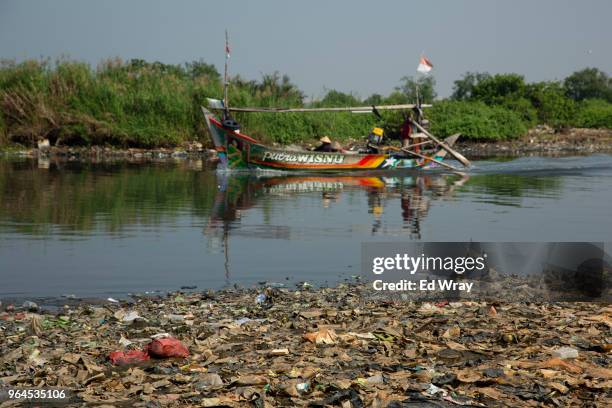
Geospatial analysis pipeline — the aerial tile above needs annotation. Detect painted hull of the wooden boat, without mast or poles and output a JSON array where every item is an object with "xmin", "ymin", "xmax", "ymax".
[{"xmin": 202, "ymin": 107, "xmax": 459, "ymax": 173}]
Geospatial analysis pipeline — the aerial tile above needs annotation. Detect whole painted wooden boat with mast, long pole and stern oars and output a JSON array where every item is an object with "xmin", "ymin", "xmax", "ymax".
[{"xmin": 202, "ymin": 31, "xmax": 469, "ymax": 173}]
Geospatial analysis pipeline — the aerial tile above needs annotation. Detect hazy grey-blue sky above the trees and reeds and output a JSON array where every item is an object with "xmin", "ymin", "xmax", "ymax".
[{"xmin": 0, "ymin": 0, "xmax": 612, "ymax": 97}]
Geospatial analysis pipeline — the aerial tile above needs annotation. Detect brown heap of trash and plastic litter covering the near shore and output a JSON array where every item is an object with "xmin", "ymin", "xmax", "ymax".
[{"xmin": 0, "ymin": 284, "xmax": 612, "ymax": 408}]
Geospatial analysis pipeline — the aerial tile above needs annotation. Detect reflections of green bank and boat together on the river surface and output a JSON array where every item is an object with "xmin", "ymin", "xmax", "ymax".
[{"xmin": 0, "ymin": 160, "xmax": 561, "ymax": 239}]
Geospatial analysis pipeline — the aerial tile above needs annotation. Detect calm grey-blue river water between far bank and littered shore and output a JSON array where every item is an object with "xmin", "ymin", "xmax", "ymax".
[{"xmin": 0, "ymin": 155, "xmax": 612, "ymax": 298}]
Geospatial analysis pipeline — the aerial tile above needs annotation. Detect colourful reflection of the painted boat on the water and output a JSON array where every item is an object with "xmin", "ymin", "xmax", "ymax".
[{"xmin": 205, "ymin": 173, "xmax": 469, "ymax": 239}]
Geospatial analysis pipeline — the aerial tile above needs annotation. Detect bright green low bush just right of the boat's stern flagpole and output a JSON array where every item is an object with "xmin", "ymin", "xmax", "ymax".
[{"xmin": 430, "ymin": 101, "xmax": 527, "ymax": 140}]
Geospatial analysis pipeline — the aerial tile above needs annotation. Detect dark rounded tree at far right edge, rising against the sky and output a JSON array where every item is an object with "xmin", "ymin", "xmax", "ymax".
[{"xmin": 563, "ymin": 68, "xmax": 612, "ymax": 102}]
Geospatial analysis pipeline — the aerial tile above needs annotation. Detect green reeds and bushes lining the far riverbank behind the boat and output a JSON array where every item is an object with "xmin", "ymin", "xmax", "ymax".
[{"xmin": 0, "ymin": 60, "xmax": 612, "ymax": 147}]
